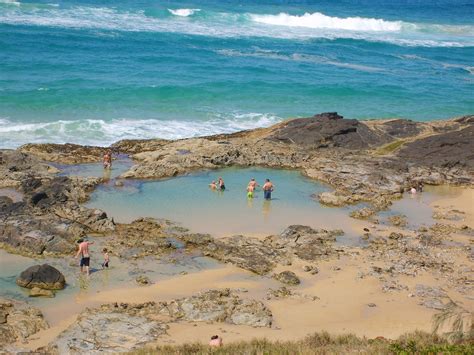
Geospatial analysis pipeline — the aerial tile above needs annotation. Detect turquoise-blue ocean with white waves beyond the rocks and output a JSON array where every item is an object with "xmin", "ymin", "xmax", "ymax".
[{"xmin": 0, "ymin": 0, "xmax": 474, "ymax": 148}]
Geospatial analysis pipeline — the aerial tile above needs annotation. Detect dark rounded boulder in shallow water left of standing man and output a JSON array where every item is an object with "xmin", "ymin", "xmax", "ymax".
[{"xmin": 16, "ymin": 264, "xmax": 66, "ymax": 290}]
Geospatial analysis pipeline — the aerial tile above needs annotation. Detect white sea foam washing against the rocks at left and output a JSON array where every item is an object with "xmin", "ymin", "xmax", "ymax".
[{"xmin": 0, "ymin": 113, "xmax": 281, "ymax": 148}]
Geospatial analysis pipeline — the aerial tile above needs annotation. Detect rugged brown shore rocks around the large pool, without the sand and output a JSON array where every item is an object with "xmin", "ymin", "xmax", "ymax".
[{"xmin": 0, "ymin": 113, "xmax": 474, "ymax": 351}]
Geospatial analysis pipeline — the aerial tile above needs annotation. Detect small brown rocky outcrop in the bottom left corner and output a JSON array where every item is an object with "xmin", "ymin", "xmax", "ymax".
[{"xmin": 0, "ymin": 298, "xmax": 48, "ymax": 352}]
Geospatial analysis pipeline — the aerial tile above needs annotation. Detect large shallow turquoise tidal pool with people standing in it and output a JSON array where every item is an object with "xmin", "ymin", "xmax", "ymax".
[{"xmin": 88, "ymin": 168, "xmax": 362, "ymax": 236}]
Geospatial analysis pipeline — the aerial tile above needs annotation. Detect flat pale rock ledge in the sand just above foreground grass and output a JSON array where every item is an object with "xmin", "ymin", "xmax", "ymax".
[{"xmin": 46, "ymin": 289, "xmax": 272, "ymax": 354}]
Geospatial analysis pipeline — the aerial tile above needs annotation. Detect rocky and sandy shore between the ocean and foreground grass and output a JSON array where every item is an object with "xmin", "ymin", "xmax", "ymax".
[{"xmin": 0, "ymin": 114, "xmax": 474, "ymax": 350}]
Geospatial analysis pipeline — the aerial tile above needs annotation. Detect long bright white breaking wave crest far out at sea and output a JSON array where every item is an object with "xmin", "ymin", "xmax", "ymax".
[{"xmin": 251, "ymin": 12, "xmax": 402, "ymax": 32}]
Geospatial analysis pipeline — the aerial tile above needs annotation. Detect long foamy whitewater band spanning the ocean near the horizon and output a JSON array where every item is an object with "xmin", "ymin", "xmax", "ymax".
[{"xmin": 0, "ymin": 5, "xmax": 474, "ymax": 47}]
